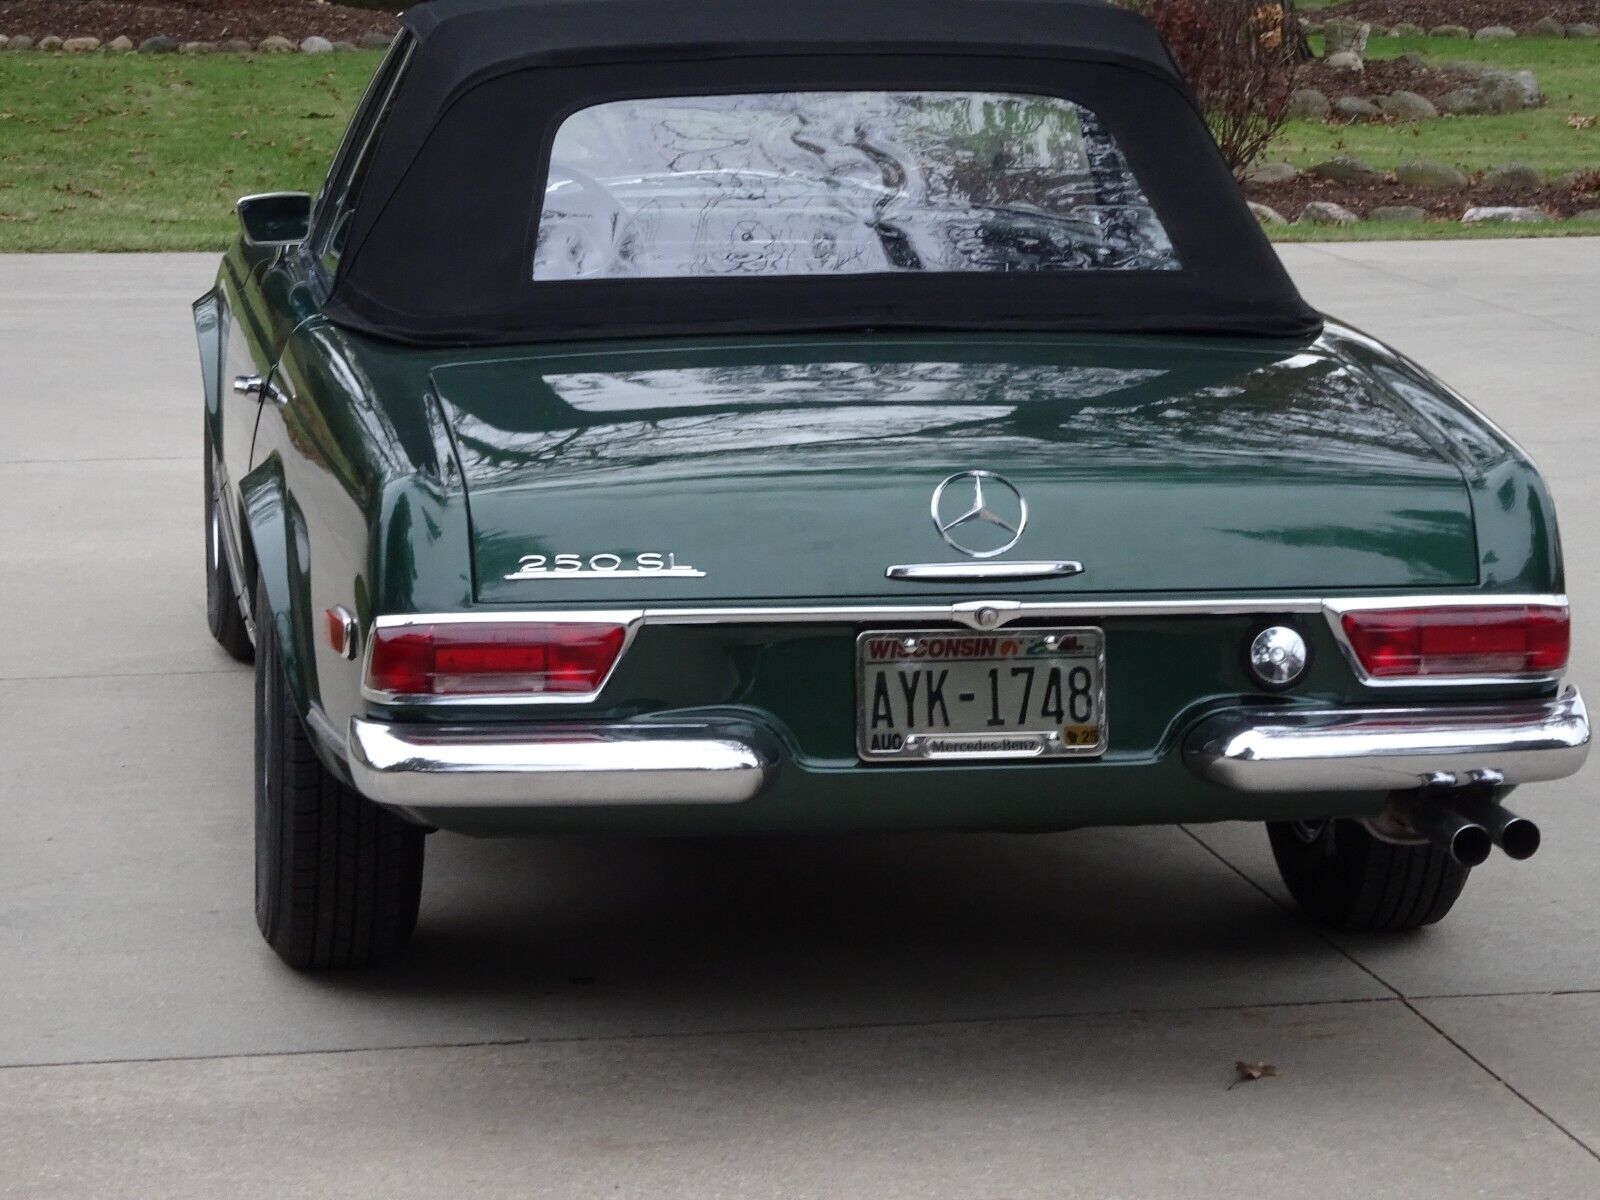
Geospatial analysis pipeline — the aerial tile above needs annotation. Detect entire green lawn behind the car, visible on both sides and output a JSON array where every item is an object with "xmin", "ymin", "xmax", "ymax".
[{"xmin": 0, "ymin": 37, "xmax": 1600, "ymax": 251}]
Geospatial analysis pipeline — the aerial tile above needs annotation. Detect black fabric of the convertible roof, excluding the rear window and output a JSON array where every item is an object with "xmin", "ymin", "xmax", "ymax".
[{"xmin": 325, "ymin": 0, "xmax": 1320, "ymax": 346}]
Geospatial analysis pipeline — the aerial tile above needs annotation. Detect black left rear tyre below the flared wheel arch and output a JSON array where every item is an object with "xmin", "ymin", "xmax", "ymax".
[{"xmin": 256, "ymin": 586, "xmax": 424, "ymax": 970}]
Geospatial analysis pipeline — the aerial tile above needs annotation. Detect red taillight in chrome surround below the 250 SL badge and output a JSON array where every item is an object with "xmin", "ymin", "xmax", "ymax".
[{"xmin": 366, "ymin": 621, "xmax": 627, "ymax": 696}]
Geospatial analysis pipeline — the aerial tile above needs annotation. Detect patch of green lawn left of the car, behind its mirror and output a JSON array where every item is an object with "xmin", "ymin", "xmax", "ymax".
[{"xmin": 0, "ymin": 51, "xmax": 381, "ymax": 251}]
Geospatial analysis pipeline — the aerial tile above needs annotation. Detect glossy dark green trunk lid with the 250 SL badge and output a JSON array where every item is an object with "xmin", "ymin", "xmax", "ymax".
[{"xmin": 434, "ymin": 338, "xmax": 1477, "ymax": 606}]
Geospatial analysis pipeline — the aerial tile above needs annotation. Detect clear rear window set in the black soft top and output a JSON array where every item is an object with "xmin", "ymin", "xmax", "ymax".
[{"xmin": 533, "ymin": 91, "xmax": 1179, "ymax": 280}]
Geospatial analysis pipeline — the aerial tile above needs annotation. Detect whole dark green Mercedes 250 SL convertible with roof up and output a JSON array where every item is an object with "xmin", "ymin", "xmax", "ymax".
[{"xmin": 195, "ymin": 0, "xmax": 1589, "ymax": 968}]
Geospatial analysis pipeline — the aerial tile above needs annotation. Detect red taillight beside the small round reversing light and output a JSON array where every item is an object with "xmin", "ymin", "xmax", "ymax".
[{"xmin": 1341, "ymin": 605, "xmax": 1570, "ymax": 678}]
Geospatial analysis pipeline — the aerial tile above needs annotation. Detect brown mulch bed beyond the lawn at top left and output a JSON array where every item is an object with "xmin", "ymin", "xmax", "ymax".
[{"xmin": 0, "ymin": 0, "xmax": 395, "ymax": 42}]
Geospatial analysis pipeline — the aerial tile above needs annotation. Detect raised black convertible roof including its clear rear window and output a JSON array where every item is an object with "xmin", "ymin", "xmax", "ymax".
[{"xmin": 323, "ymin": 0, "xmax": 1320, "ymax": 346}]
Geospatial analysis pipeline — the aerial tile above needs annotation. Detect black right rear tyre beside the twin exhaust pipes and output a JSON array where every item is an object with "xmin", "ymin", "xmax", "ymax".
[{"xmin": 1267, "ymin": 821, "xmax": 1472, "ymax": 933}]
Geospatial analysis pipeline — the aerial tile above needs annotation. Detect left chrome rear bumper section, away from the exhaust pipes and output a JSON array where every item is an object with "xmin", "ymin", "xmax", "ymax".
[{"xmin": 349, "ymin": 717, "xmax": 778, "ymax": 810}]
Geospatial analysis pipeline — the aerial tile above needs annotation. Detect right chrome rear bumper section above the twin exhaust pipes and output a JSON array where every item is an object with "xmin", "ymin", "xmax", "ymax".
[{"xmin": 1184, "ymin": 688, "xmax": 1589, "ymax": 792}]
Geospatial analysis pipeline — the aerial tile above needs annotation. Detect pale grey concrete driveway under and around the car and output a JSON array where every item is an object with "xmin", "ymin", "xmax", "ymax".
[{"xmin": 0, "ymin": 240, "xmax": 1600, "ymax": 1200}]
